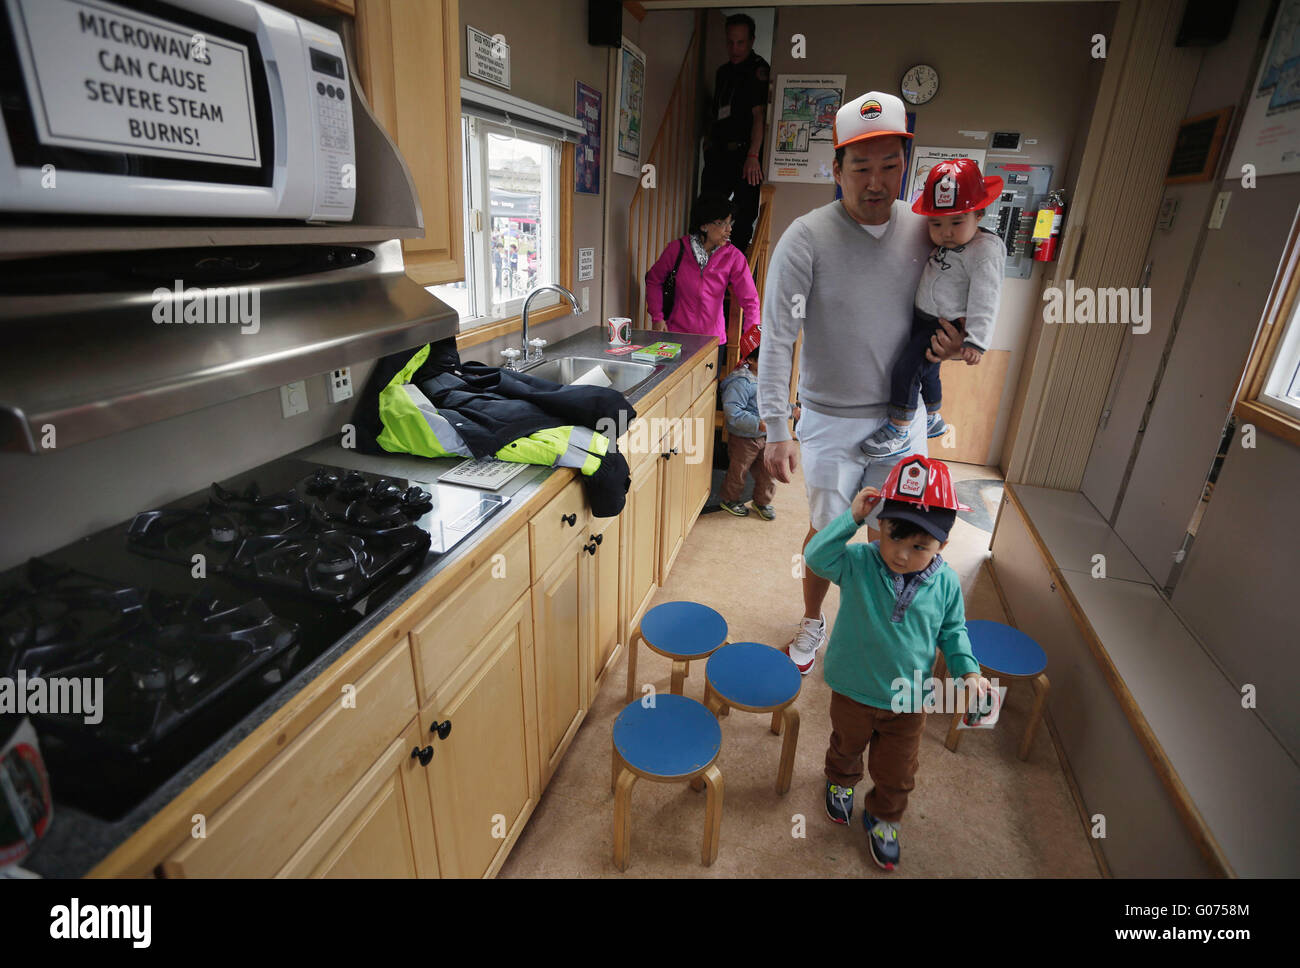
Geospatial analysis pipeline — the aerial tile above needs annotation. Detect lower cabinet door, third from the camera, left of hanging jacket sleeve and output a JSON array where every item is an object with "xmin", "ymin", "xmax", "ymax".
[{"xmin": 533, "ymin": 540, "xmax": 590, "ymax": 787}]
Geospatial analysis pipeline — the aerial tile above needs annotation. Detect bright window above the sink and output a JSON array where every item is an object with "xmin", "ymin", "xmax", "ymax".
[{"xmin": 429, "ymin": 117, "xmax": 562, "ymax": 333}]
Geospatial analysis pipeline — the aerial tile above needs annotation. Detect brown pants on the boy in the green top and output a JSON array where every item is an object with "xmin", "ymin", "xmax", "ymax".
[{"xmin": 826, "ymin": 693, "xmax": 926, "ymax": 824}]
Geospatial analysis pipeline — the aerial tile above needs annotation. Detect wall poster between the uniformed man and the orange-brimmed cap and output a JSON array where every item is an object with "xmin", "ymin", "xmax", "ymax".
[{"xmin": 767, "ymin": 74, "xmax": 848, "ymax": 185}]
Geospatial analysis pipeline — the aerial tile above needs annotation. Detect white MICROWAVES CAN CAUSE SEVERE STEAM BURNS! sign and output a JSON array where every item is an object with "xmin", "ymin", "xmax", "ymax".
[{"xmin": 8, "ymin": 0, "xmax": 261, "ymax": 168}]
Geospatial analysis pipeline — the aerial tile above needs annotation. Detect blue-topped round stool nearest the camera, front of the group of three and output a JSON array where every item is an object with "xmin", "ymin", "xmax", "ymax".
[{"xmin": 610, "ymin": 694, "xmax": 723, "ymax": 871}]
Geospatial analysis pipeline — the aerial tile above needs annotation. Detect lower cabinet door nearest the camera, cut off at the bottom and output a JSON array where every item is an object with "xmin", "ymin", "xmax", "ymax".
[{"xmin": 276, "ymin": 719, "xmax": 438, "ymax": 877}]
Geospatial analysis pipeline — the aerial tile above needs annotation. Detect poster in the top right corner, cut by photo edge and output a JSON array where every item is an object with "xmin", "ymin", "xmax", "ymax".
[{"xmin": 1223, "ymin": 0, "xmax": 1300, "ymax": 178}]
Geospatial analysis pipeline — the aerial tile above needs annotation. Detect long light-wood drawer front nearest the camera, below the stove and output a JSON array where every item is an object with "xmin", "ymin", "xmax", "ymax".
[{"xmin": 163, "ymin": 639, "xmax": 417, "ymax": 877}]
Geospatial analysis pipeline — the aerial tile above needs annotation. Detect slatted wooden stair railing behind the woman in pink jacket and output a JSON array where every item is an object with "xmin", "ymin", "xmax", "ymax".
[{"xmin": 628, "ymin": 16, "xmax": 703, "ymax": 329}]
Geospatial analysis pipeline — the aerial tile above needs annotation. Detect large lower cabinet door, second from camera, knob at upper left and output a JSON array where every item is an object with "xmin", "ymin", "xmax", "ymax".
[{"xmin": 419, "ymin": 594, "xmax": 538, "ymax": 877}]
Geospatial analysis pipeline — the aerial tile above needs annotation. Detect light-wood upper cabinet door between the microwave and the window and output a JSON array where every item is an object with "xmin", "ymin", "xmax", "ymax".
[{"xmin": 356, "ymin": 0, "xmax": 465, "ymax": 286}]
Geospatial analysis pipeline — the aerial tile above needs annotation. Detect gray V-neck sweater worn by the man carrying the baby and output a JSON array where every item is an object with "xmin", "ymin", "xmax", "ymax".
[{"xmin": 758, "ymin": 199, "xmax": 932, "ymax": 443}]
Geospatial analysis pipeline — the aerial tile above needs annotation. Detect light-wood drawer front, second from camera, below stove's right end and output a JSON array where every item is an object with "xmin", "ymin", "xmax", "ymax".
[{"xmin": 411, "ymin": 527, "xmax": 525, "ymax": 703}]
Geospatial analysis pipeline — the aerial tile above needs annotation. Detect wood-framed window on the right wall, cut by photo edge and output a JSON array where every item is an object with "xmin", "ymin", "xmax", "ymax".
[{"xmin": 1235, "ymin": 209, "xmax": 1300, "ymax": 446}]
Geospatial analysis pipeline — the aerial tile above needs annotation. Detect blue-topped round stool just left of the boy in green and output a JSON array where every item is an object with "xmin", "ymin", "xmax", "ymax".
[{"xmin": 705, "ymin": 642, "xmax": 803, "ymax": 794}]
